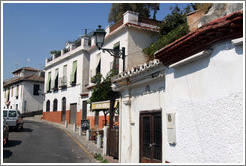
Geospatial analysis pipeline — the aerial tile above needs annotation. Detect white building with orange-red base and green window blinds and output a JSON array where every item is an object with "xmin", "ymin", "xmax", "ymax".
[{"xmin": 43, "ymin": 36, "xmax": 90, "ymax": 124}]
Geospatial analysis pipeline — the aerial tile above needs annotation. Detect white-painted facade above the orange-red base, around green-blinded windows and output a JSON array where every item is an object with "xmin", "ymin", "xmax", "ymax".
[{"xmin": 43, "ymin": 37, "xmax": 90, "ymax": 123}]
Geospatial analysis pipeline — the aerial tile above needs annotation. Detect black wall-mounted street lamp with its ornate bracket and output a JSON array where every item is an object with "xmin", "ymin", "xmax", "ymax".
[{"xmin": 93, "ymin": 25, "xmax": 125, "ymax": 71}]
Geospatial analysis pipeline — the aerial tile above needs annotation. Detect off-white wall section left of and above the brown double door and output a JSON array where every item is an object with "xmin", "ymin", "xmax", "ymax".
[{"xmin": 119, "ymin": 79, "xmax": 165, "ymax": 163}]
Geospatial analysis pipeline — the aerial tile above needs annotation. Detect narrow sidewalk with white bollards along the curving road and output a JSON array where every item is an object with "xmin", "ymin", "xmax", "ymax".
[{"xmin": 24, "ymin": 116, "xmax": 118, "ymax": 163}]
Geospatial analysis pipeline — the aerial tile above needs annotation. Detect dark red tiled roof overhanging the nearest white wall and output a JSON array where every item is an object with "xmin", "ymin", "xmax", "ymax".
[{"xmin": 155, "ymin": 11, "xmax": 243, "ymax": 66}]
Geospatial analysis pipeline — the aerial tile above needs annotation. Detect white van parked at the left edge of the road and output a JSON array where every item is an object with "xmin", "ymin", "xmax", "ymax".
[{"xmin": 3, "ymin": 109, "xmax": 24, "ymax": 131}]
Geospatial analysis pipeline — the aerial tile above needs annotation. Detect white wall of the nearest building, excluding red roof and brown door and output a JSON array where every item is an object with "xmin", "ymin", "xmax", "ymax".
[{"xmin": 114, "ymin": 39, "xmax": 244, "ymax": 163}]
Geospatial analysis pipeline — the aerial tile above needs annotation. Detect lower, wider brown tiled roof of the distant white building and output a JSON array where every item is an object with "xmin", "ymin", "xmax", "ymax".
[{"xmin": 3, "ymin": 74, "xmax": 44, "ymax": 87}]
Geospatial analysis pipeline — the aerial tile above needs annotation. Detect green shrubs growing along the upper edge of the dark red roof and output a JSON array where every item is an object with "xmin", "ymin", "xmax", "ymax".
[{"xmin": 144, "ymin": 23, "xmax": 189, "ymax": 60}]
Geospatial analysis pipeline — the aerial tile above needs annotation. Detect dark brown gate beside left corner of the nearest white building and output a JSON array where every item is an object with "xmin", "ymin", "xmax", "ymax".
[{"xmin": 107, "ymin": 128, "xmax": 119, "ymax": 159}]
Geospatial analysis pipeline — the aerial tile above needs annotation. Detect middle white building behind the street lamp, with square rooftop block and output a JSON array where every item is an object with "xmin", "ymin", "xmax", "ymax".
[{"xmin": 87, "ymin": 11, "xmax": 159, "ymax": 128}]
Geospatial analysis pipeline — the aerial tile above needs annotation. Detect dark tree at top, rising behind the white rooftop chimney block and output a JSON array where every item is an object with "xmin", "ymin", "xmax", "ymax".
[{"xmin": 108, "ymin": 3, "xmax": 160, "ymax": 23}]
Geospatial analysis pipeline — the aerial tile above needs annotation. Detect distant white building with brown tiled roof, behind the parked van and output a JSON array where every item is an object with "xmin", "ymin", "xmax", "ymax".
[{"xmin": 3, "ymin": 67, "xmax": 44, "ymax": 114}]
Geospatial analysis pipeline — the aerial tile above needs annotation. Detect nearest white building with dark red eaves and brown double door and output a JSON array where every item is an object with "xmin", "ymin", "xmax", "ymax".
[{"xmin": 113, "ymin": 11, "xmax": 245, "ymax": 163}]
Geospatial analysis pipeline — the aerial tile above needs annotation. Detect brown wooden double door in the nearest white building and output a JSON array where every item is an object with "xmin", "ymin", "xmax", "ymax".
[{"xmin": 140, "ymin": 111, "xmax": 162, "ymax": 163}]
